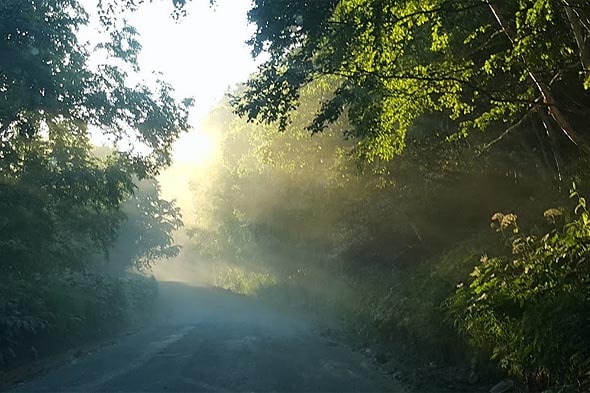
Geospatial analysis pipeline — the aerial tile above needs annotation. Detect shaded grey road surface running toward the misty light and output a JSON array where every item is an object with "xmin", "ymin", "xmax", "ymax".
[{"xmin": 12, "ymin": 283, "xmax": 404, "ymax": 393}]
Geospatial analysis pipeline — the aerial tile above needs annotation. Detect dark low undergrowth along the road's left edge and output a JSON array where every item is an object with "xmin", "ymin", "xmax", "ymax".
[{"xmin": 0, "ymin": 270, "xmax": 157, "ymax": 368}]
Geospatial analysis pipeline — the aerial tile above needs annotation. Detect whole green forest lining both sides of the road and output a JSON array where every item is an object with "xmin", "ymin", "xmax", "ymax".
[{"xmin": 0, "ymin": 0, "xmax": 590, "ymax": 392}]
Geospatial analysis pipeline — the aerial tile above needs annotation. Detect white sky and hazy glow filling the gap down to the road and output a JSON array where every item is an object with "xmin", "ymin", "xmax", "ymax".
[{"xmin": 80, "ymin": 0, "xmax": 264, "ymax": 285}]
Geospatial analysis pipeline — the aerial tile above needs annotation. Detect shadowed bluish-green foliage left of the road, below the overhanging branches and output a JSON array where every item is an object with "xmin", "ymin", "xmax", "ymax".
[{"xmin": 0, "ymin": 132, "xmax": 181, "ymax": 366}]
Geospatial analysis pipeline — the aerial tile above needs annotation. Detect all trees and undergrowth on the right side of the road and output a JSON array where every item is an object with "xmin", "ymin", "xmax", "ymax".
[{"xmin": 190, "ymin": 0, "xmax": 590, "ymax": 391}]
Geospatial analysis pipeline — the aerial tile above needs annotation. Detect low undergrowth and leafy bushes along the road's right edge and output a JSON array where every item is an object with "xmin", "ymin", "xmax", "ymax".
[{"xmin": 223, "ymin": 188, "xmax": 590, "ymax": 391}]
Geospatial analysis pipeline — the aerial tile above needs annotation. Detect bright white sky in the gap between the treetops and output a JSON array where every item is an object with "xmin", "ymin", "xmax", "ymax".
[{"xmin": 83, "ymin": 0, "xmax": 257, "ymax": 163}]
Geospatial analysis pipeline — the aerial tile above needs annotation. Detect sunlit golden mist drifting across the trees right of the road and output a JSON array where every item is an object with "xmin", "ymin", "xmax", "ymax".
[{"xmin": 148, "ymin": 82, "xmax": 529, "ymax": 329}]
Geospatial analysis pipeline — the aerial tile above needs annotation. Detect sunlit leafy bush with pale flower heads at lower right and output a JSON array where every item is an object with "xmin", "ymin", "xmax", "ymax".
[{"xmin": 451, "ymin": 188, "xmax": 590, "ymax": 387}]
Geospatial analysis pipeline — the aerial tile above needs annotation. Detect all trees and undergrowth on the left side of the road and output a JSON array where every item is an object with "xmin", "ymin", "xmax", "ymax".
[{"xmin": 0, "ymin": 0, "xmax": 185, "ymax": 370}]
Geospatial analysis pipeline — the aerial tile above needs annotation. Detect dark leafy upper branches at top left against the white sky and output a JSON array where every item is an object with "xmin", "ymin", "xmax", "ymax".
[{"xmin": 0, "ymin": 0, "xmax": 192, "ymax": 177}]
